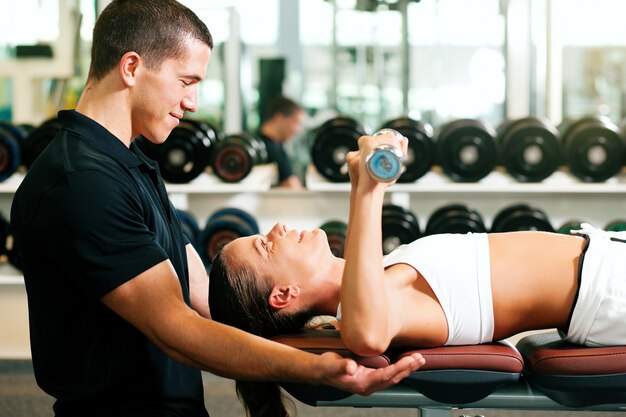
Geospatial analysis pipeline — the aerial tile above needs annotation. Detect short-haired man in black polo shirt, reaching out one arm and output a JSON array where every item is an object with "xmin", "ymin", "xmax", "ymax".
[{"xmin": 11, "ymin": 0, "xmax": 424, "ymax": 417}]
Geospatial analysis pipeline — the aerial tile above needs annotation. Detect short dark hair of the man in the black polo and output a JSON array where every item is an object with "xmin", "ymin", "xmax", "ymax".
[{"xmin": 89, "ymin": 0, "xmax": 213, "ymax": 81}]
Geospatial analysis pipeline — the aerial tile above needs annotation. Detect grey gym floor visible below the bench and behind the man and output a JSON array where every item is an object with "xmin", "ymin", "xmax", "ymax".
[{"xmin": 0, "ymin": 360, "xmax": 624, "ymax": 417}]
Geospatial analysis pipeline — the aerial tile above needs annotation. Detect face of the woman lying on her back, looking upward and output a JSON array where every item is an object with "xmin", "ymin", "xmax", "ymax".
[{"xmin": 227, "ymin": 223, "xmax": 334, "ymax": 285}]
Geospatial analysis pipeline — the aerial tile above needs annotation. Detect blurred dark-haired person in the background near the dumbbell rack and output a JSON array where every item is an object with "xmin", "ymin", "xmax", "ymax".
[{"xmin": 257, "ymin": 96, "xmax": 306, "ymax": 190}]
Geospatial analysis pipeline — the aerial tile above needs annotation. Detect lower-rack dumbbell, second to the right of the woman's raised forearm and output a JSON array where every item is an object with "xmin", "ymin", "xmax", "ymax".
[{"xmin": 424, "ymin": 204, "xmax": 487, "ymax": 235}]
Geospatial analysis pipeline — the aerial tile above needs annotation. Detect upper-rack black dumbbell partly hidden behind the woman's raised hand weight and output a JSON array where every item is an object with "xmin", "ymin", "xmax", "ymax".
[{"xmin": 381, "ymin": 117, "xmax": 436, "ymax": 183}]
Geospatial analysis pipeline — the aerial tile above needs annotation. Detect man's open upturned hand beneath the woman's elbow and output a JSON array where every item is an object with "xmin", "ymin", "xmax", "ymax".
[{"xmin": 318, "ymin": 352, "xmax": 425, "ymax": 395}]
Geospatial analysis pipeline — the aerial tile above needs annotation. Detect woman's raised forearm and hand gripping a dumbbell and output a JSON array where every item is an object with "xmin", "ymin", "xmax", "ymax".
[{"xmin": 341, "ymin": 134, "xmax": 407, "ymax": 356}]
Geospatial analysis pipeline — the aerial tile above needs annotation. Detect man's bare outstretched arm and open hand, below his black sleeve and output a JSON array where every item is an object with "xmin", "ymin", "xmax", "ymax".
[{"xmin": 102, "ymin": 261, "xmax": 423, "ymax": 395}]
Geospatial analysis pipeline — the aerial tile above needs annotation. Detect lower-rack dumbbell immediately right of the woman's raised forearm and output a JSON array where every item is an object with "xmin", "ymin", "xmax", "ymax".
[{"xmin": 382, "ymin": 204, "xmax": 421, "ymax": 255}]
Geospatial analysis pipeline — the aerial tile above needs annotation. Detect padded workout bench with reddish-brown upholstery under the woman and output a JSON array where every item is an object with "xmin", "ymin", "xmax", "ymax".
[{"xmin": 274, "ymin": 330, "xmax": 626, "ymax": 417}]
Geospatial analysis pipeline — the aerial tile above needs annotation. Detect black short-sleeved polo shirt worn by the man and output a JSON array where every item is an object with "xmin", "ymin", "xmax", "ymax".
[{"xmin": 11, "ymin": 111, "xmax": 207, "ymax": 417}]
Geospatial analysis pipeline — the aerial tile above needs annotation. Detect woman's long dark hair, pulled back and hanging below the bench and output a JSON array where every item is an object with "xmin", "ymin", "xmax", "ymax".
[{"xmin": 209, "ymin": 246, "xmax": 313, "ymax": 417}]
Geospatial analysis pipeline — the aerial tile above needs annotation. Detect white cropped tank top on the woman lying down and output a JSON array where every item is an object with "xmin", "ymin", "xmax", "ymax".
[{"xmin": 383, "ymin": 233, "xmax": 494, "ymax": 345}]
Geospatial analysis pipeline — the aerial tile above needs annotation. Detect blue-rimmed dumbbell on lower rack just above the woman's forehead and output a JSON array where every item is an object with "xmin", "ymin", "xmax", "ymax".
[{"xmin": 198, "ymin": 207, "xmax": 259, "ymax": 266}]
